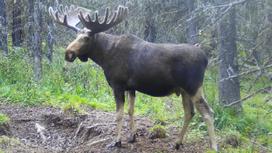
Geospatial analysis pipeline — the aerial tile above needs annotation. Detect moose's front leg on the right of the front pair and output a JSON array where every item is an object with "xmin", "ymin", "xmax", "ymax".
[{"xmin": 128, "ymin": 91, "xmax": 136, "ymax": 143}]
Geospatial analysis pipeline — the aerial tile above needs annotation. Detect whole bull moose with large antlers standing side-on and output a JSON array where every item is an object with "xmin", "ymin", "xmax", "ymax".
[{"xmin": 49, "ymin": 5, "xmax": 217, "ymax": 150}]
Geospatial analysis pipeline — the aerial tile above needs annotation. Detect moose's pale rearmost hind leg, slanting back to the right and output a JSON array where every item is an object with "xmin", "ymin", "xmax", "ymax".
[{"xmin": 192, "ymin": 87, "xmax": 218, "ymax": 151}]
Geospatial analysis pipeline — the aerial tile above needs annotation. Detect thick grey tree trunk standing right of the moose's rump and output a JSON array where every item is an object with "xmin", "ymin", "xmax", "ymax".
[{"xmin": 218, "ymin": 6, "xmax": 242, "ymax": 113}]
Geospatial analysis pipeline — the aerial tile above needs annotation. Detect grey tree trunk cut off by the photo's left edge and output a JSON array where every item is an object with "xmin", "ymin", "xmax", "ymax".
[{"xmin": 0, "ymin": 0, "xmax": 8, "ymax": 56}]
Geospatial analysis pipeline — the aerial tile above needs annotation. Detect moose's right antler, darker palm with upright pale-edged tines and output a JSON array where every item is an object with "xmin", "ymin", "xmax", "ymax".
[{"xmin": 78, "ymin": 6, "xmax": 128, "ymax": 34}]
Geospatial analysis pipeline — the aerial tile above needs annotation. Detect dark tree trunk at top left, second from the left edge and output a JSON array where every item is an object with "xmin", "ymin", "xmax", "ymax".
[{"xmin": 12, "ymin": 0, "xmax": 23, "ymax": 47}]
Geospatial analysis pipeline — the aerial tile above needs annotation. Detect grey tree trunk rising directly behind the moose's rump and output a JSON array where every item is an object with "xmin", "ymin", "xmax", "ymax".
[{"xmin": 186, "ymin": 0, "xmax": 198, "ymax": 44}]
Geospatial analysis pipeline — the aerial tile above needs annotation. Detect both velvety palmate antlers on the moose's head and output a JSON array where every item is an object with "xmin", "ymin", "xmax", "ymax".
[{"xmin": 49, "ymin": 5, "xmax": 128, "ymax": 34}]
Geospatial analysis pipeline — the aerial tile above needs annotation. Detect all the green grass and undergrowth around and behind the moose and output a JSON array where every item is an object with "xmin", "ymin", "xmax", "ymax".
[{"xmin": 0, "ymin": 49, "xmax": 272, "ymax": 152}]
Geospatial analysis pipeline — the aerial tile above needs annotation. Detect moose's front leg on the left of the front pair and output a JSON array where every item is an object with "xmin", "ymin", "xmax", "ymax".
[{"xmin": 111, "ymin": 89, "xmax": 125, "ymax": 147}]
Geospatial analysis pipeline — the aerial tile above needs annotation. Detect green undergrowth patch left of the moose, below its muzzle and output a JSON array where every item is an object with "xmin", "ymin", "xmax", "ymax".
[{"xmin": 0, "ymin": 47, "xmax": 113, "ymax": 106}]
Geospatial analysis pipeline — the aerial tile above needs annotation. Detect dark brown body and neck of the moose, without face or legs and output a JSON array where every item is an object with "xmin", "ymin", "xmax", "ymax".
[{"xmin": 71, "ymin": 33, "xmax": 207, "ymax": 96}]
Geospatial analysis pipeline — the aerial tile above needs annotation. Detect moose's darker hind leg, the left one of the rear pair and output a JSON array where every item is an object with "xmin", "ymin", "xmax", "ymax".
[{"xmin": 176, "ymin": 92, "xmax": 195, "ymax": 149}]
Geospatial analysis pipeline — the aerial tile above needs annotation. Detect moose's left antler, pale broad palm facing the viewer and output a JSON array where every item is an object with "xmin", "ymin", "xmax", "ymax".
[{"xmin": 49, "ymin": 5, "xmax": 90, "ymax": 32}]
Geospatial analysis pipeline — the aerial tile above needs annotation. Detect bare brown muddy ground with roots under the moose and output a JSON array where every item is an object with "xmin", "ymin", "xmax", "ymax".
[{"xmin": 0, "ymin": 104, "xmax": 209, "ymax": 153}]
